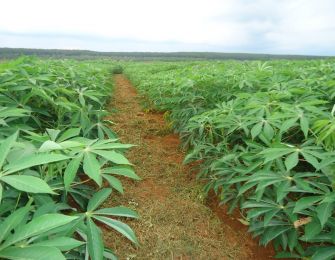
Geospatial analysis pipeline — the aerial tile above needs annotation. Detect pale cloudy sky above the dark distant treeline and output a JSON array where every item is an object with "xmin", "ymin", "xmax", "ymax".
[{"xmin": 0, "ymin": 0, "xmax": 335, "ymax": 55}]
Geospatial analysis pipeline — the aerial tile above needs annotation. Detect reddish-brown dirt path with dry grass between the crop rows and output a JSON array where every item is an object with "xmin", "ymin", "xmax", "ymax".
[{"xmin": 105, "ymin": 75, "xmax": 273, "ymax": 259}]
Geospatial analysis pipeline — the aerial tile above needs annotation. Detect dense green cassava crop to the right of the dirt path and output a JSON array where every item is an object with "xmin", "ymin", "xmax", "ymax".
[{"xmin": 124, "ymin": 60, "xmax": 335, "ymax": 259}]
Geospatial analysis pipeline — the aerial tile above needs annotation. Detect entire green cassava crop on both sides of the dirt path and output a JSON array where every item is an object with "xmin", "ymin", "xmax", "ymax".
[{"xmin": 0, "ymin": 57, "xmax": 335, "ymax": 260}]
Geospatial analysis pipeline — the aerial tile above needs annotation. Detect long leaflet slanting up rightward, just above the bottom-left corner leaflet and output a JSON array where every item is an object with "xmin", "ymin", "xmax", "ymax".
[{"xmin": 0, "ymin": 213, "xmax": 78, "ymax": 250}]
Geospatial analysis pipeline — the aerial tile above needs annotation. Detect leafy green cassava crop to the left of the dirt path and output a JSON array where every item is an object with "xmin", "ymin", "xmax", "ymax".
[{"xmin": 0, "ymin": 58, "xmax": 139, "ymax": 260}]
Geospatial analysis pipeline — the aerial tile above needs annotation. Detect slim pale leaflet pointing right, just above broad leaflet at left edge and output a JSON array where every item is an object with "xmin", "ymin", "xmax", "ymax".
[{"xmin": 4, "ymin": 153, "xmax": 70, "ymax": 174}]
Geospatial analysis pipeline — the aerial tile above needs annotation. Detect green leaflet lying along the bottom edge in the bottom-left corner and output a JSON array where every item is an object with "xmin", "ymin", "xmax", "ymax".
[{"xmin": 0, "ymin": 246, "xmax": 65, "ymax": 260}]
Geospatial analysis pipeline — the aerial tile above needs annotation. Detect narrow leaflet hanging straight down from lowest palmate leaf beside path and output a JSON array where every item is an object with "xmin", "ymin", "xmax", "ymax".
[{"xmin": 87, "ymin": 218, "xmax": 104, "ymax": 260}]
